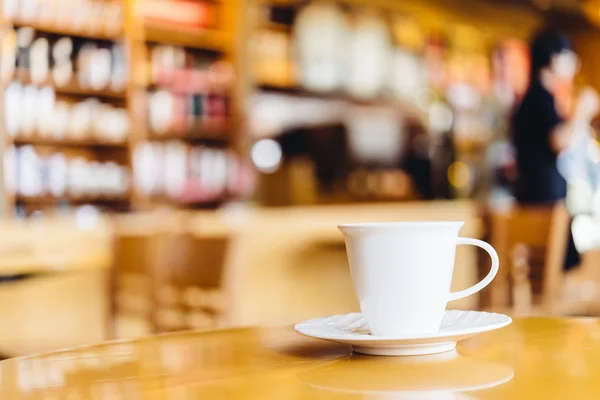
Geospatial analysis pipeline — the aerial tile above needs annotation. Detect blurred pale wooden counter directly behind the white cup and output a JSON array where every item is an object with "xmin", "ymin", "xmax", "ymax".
[{"xmin": 189, "ymin": 201, "xmax": 483, "ymax": 325}]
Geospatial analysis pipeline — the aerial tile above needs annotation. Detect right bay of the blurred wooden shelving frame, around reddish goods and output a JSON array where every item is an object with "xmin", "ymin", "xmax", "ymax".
[{"xmin": 132, "ymin": 0, "xmax": 245, "ymax": 209}]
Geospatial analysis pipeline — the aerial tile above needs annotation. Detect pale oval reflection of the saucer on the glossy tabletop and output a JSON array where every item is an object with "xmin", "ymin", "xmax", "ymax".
[{"xmin": 299, "ymin": 350, "xmax": 514, "ymax": 399}]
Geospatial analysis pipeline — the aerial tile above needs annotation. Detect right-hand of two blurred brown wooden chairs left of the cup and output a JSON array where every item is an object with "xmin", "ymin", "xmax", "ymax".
[{"xmin": 154, "ymin": 231, "xmax": 237, "ymax": 332}]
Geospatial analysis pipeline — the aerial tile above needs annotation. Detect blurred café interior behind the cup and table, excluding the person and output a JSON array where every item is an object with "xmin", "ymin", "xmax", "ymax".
[{"xmin": 0, "ymin": 0, "xmax": 600, "ymax": 356}]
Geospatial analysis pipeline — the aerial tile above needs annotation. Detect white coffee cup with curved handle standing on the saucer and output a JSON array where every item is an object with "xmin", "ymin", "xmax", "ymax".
[{"xmin": 338, "ymin": 221, "xmax": 498, "ymax": 336}]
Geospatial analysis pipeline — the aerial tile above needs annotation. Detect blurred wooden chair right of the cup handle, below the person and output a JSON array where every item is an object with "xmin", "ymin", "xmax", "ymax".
[{"xmin": 489, "ymin": 203, "xmax": 592, "ymax": 315}]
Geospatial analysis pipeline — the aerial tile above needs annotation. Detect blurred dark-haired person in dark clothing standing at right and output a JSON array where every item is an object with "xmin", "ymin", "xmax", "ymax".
[{"xmin": 513, "ymin": 30, "xmax": 595, "ymax": 269}]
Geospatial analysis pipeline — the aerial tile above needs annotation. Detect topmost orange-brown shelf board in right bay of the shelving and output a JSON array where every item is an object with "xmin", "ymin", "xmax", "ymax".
[{"xmin": 144, "ymin": 22, "xmax": 232, "ymax": 53}]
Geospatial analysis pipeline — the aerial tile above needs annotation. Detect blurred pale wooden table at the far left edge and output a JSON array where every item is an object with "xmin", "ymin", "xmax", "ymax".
[{"xmin": 0, "ymin": 219, "xmax": 112, "ymax": 356}]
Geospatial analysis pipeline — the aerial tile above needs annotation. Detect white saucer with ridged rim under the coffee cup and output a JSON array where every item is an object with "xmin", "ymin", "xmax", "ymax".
[{"xmin": 295, "ymin": 310, "xmax": 512, "ymax": 356}]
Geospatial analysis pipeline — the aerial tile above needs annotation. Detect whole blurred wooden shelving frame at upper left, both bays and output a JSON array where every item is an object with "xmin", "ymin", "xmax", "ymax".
[{"xmin": 0, "ymin": 0, "xmax": 243, "ymax": 215}]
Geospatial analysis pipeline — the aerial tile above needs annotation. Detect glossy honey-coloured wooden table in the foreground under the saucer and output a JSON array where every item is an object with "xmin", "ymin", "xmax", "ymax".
[{"xmin": 0, "ymin": 319, "xmax": 600, "ymax": 400}]
